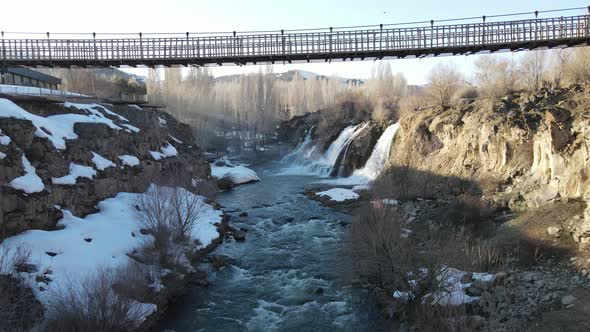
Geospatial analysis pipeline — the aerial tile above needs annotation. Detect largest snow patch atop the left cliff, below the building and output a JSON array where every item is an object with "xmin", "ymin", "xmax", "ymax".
[{"xmin": 0, "ymin": 98, "xmax": 122, "ymax": 150}]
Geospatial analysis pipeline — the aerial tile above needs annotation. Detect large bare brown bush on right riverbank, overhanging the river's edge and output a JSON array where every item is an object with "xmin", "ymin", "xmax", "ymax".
[{"xmin": 351, "ymin": 207, "xmax": 461, "ymax": 316}]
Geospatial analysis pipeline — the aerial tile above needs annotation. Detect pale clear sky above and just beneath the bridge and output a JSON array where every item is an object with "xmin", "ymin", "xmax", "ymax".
[{"xmin": 0, "ymin": 0, "xmax": 590, "ymax": 84}]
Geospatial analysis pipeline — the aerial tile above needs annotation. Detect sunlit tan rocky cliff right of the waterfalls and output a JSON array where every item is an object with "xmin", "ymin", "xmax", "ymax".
[{"xmin": 390, "ymin": 86, "xmax": 590, "ymax": 241}]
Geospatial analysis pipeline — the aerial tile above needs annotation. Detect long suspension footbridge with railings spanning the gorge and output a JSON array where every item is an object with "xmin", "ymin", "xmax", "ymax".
[{"xmin": 0, "ymin": 7, "xmax": 590, "ymax": 68}]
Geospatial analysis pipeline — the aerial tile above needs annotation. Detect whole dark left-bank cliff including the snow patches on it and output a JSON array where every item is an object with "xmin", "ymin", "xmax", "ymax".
[{"xmin": 0, "ymin": 99, "xmax": 210, "ymax": 238}]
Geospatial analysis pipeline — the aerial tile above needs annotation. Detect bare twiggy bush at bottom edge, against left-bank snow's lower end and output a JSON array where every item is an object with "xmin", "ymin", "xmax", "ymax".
[{"xmin": 47, "ymin": 269, "xmax": 149, "ymax": 332}]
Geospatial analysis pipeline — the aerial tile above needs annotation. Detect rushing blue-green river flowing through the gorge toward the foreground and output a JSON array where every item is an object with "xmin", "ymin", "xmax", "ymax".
[{"xmin": 159, "ymin": 163, "xmax": 380, "ymax": 331}]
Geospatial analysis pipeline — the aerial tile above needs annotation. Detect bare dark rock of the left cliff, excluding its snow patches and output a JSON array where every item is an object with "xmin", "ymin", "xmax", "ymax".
[{"xmin": 0, "ymin": 102, "xmax": 210, "ymax": 238}]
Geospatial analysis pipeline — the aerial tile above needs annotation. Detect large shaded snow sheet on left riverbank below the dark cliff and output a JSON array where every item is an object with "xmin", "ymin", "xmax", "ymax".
[{"xmin": 0, "ymin": 186, "xmax": 222, "ymax": 315}]
